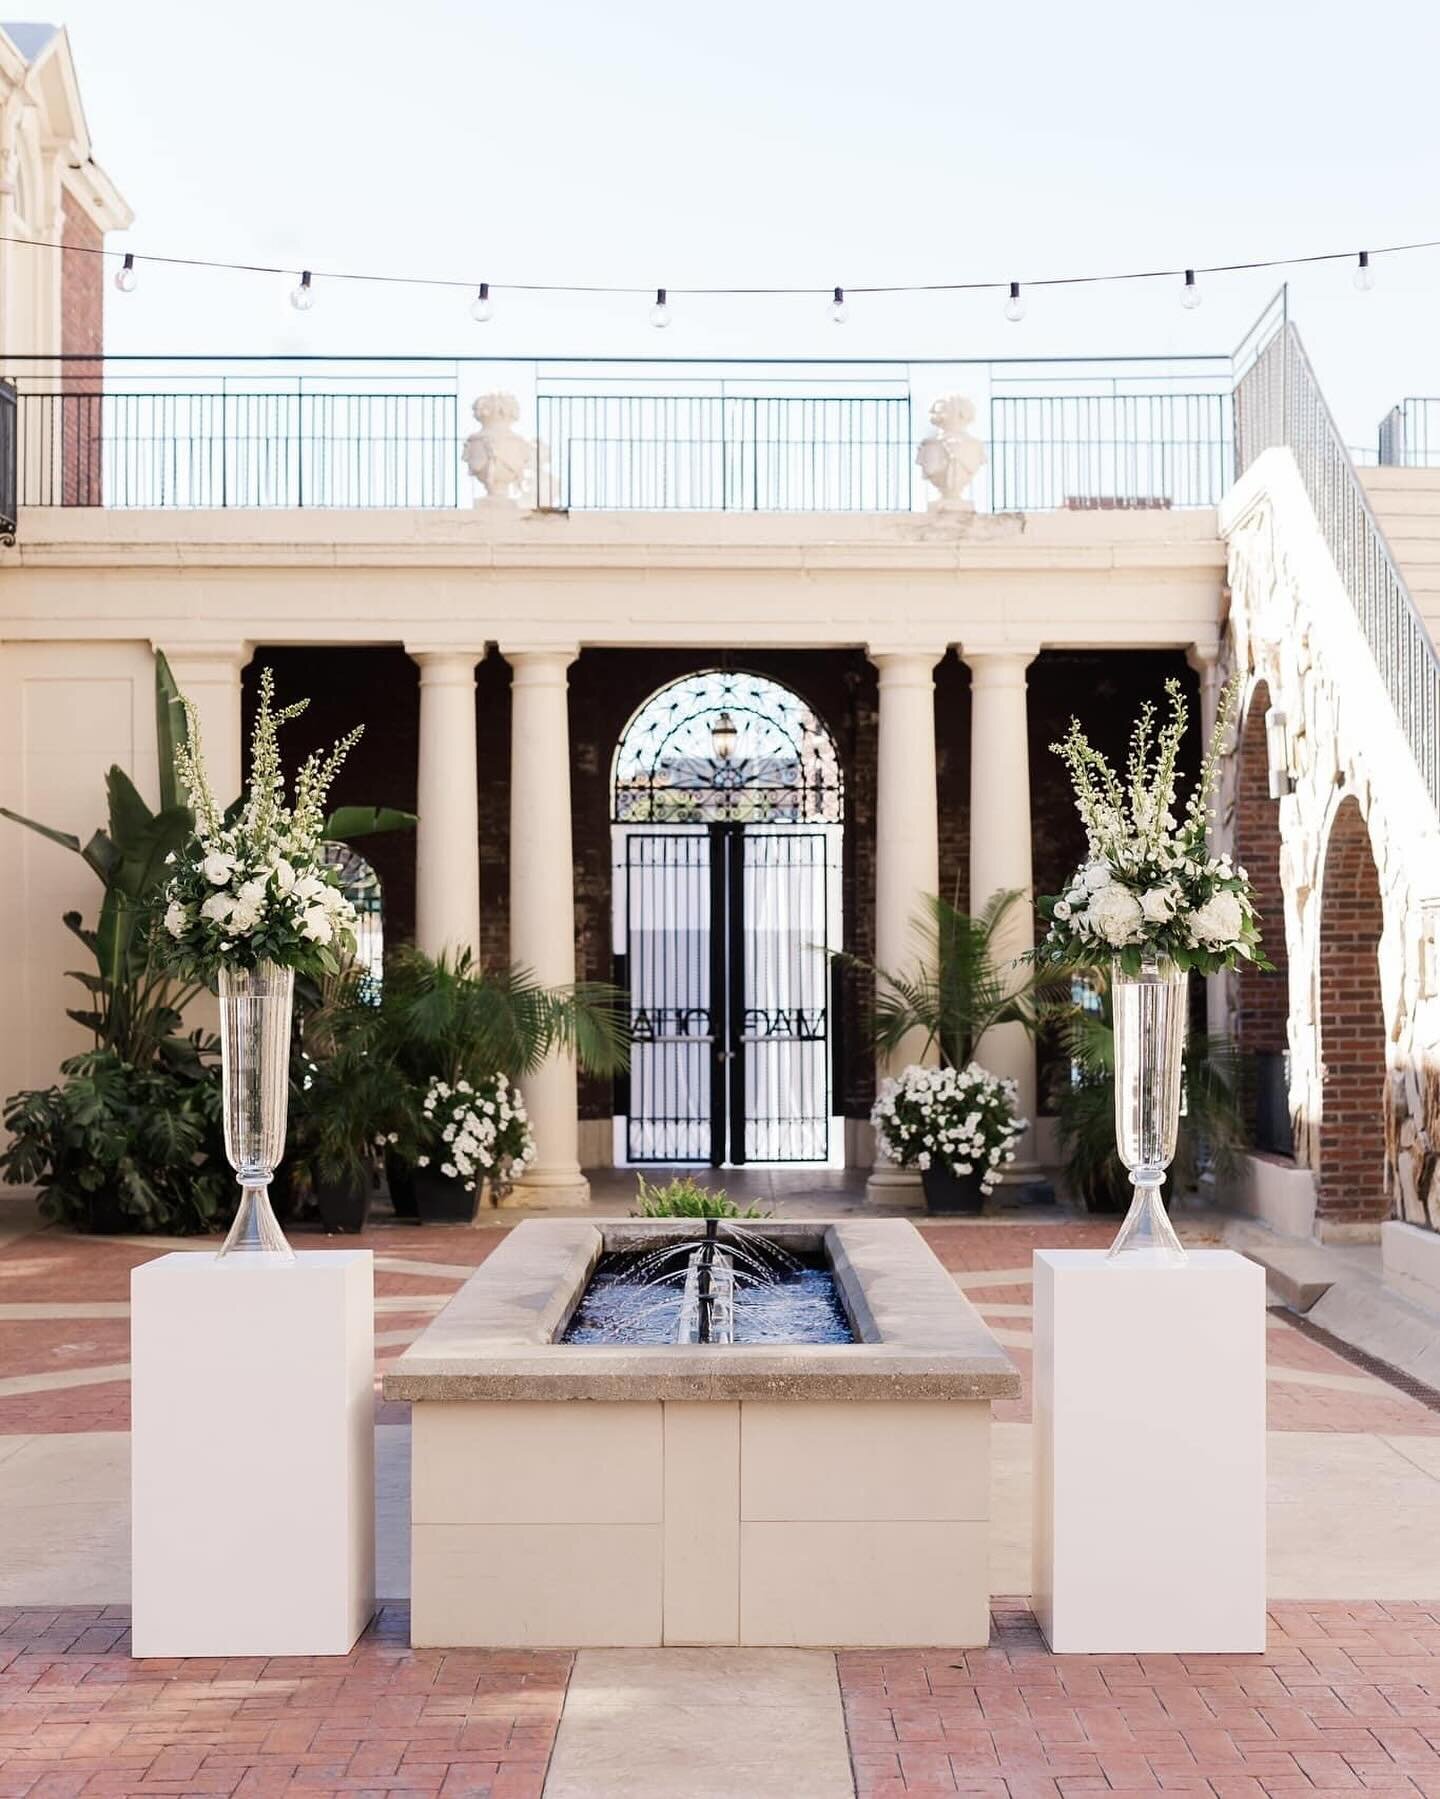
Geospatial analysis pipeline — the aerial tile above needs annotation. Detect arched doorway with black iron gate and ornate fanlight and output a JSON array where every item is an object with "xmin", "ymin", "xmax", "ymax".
[{"xmin": 610, "ymin": 669, "xmax": 844, "ymax": 1166}]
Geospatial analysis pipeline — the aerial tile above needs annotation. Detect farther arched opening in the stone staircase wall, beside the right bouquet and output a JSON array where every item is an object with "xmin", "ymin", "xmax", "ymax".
[{"xmin": 1235, "ymin": 682, "xmax": 1294, "ymax": 1155}]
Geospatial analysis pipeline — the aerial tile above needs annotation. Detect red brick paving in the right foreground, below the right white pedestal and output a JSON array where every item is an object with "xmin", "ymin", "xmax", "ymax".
[{"xmin": 839, "ymin": 1599, "xmax": 1440, "ymax": 1799}]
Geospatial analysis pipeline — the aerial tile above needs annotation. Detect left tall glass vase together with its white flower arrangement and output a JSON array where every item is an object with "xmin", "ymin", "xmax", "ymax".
[{"xmin": 160, "ymin": 669, "xmax": 360, "ymax": 1258}]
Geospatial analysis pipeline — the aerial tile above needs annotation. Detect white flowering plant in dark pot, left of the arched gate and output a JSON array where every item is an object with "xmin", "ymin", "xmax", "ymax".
[{"xmin": 414, "ymin": 1074, "xmax": 535, "ymax": 1223}]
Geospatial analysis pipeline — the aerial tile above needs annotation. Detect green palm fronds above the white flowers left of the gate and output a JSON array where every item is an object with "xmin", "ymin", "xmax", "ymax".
[{"xmin": 380, "ymin": 948, "xmax": 630, "ymax": 1092}]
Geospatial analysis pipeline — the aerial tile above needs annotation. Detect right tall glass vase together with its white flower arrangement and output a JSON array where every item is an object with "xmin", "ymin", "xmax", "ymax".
[{"xmin": 1035, "ymin": 680, "xmax": 1269, "ymax": 1265}]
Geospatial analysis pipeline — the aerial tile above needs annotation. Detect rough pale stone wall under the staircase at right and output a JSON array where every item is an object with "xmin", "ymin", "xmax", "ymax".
[{"xmin": 1219, "ymin": 452, "xmax": 1440, "ymax": 1236}]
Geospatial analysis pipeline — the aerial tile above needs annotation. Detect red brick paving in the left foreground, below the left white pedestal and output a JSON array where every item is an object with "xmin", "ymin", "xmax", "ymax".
[{"xmin": 0, "ymin": 1607, "xmax": 572, "ymax": 1799}]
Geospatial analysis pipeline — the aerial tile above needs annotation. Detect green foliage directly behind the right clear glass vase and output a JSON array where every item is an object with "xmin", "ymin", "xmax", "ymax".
[{"xmin": 1057, "ymin": 984, "xmax": 1246, "ymax": 1211}]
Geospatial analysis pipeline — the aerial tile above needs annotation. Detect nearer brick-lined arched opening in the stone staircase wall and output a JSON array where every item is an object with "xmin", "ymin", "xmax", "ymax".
[{"xmin": 1318, "ymin": 799, "xmax": 1388, "ymax": 1223}]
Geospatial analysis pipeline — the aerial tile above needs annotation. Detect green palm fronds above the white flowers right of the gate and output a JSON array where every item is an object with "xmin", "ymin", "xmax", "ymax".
[{"xmin": 846, "ymin": 891, "xmax": 1069, "ymax": 1069}]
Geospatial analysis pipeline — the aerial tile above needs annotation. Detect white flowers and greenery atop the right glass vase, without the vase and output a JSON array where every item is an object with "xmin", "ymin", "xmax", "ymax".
[{"xmin": 1035, "ymin": 680, "xmax": 1269, "ymax": 975}]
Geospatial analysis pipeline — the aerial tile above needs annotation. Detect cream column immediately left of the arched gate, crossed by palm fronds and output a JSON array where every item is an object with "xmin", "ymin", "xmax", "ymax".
[{"xmin": 500, "ymin": 644, "xmax": 590, "ymax": 1205}]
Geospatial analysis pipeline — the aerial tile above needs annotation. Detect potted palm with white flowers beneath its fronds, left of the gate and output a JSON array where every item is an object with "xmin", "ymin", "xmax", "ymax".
[{"xmin": 378, "ymin": 948, "xmax": 628, "ymax": 1222}]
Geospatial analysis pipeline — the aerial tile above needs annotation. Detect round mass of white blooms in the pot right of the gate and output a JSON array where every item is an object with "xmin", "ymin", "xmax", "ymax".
[{"xmin": 869, "ymin": 1061, "xmax": 1028, "ymax": 1193}]
